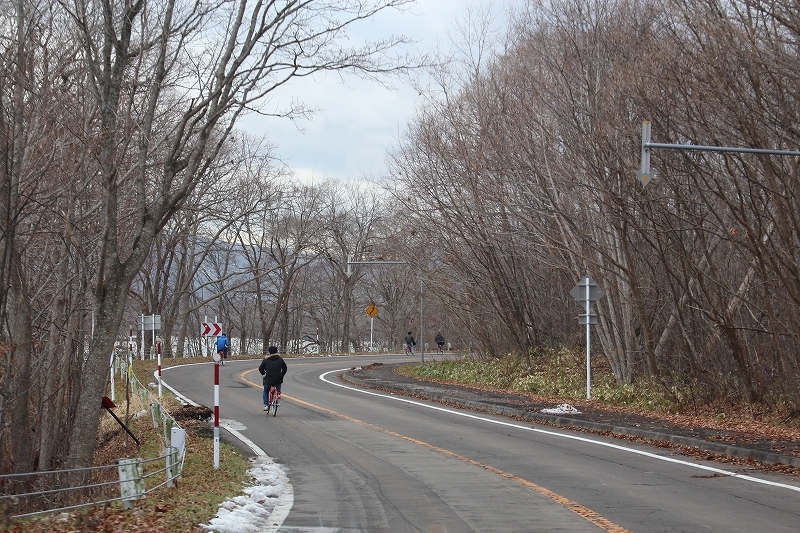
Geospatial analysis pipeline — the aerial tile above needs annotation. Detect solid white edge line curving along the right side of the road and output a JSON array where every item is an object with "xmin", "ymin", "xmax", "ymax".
[{"xmin": 319, "ymin": 368, "xmax": 800, "ymax": 492}]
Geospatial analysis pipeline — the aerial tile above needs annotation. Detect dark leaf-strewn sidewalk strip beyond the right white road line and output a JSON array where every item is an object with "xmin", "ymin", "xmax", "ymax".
[{"xmin": 343, "ymin": 363, "xmax": 800, "ymax": 468}]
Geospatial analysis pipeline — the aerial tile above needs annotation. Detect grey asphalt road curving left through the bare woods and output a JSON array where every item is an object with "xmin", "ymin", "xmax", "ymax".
[{"xmin": 163, "ymin": 356, "xmax": 800, "ymax": 533}]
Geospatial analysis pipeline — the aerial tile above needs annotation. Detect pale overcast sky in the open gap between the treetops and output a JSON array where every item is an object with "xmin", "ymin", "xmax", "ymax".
[{"xmin": 242, "ymin": 0, "xmax": 522, "ymax": 180}]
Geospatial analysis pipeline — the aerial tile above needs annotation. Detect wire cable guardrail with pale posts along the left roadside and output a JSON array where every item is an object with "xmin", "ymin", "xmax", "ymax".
[{"xmin": 0, "ymin": 369, "xmax": 186, "ymax": 519}]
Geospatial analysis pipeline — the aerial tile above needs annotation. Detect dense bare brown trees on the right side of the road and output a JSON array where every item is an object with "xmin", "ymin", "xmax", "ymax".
[{"xmin": 393, "ymin": 0, "xmax": 800, "ymax": 413}]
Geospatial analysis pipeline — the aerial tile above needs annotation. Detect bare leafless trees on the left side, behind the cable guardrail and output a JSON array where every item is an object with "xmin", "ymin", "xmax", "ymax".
[{"xmin": 0, "ymin": 0, "xmax": 422, "ymax": 472}]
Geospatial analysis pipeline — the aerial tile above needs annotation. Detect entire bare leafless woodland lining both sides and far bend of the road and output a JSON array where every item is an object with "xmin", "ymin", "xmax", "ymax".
[{"xmin": 0, "ymin": 0, "xmax": 800, "ymax": 478}]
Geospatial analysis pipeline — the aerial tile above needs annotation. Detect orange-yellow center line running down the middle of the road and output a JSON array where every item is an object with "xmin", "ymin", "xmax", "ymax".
[{"xmin": 239, "ymin": 371, "xmax": 631, "ymax": 533}]
